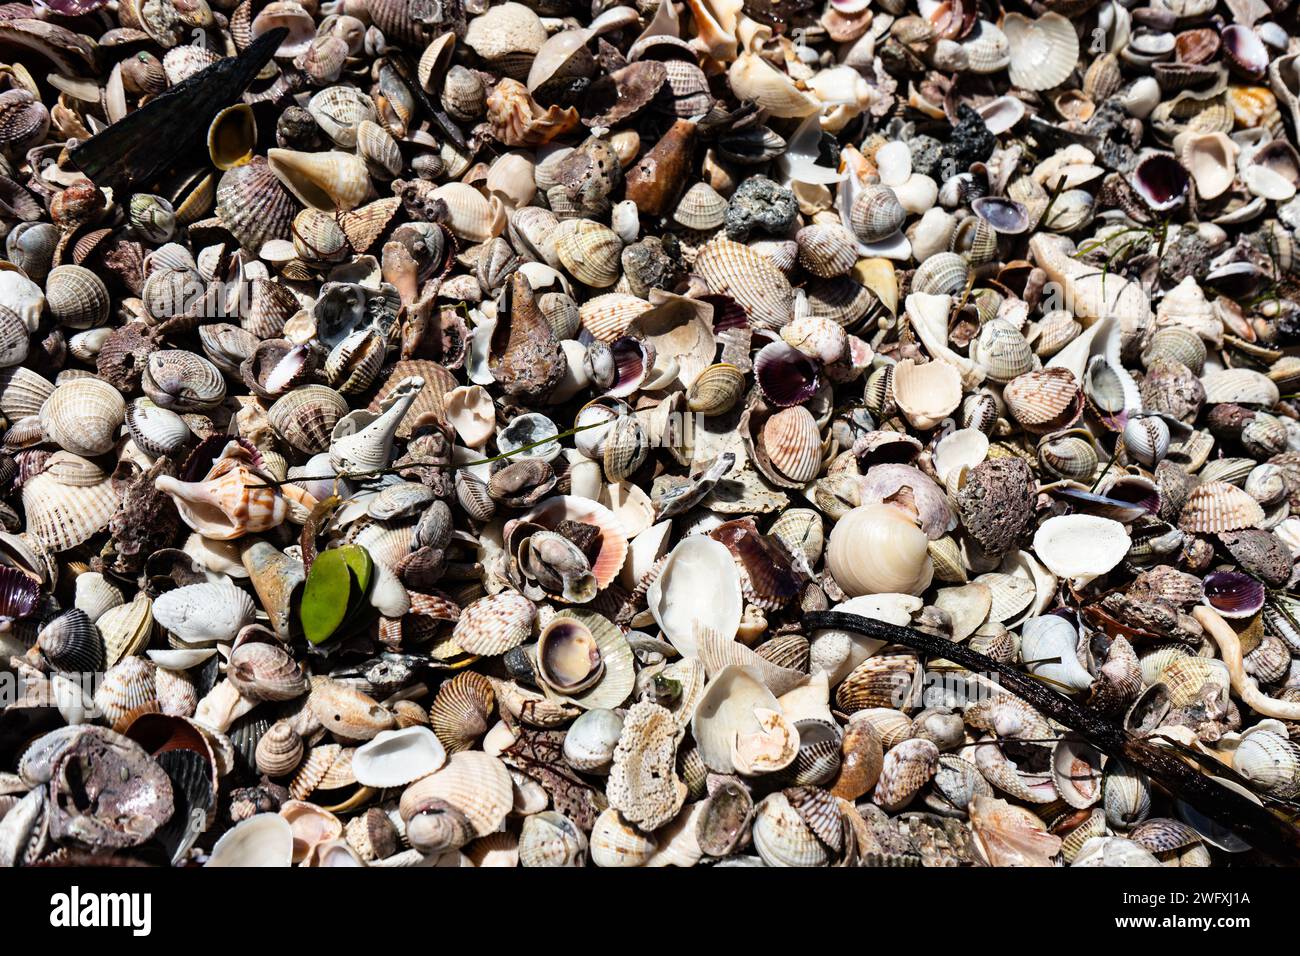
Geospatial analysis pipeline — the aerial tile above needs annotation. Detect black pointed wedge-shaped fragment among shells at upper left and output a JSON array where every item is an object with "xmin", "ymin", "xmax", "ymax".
[{"xmin": 72, "ymin": 26, "xmax": 289, "ymax": 191}]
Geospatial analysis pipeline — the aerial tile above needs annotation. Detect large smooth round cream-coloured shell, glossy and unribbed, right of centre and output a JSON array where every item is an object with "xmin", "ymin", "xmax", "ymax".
[{"xmin": 826, "ymin": 505, "xmax": 933, "ymax": 597}]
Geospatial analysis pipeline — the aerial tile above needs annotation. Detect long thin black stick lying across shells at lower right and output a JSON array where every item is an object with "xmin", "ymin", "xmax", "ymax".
[{"xmin": 803, "ymin": 611, "xmax": 1300, "ymax": 864}]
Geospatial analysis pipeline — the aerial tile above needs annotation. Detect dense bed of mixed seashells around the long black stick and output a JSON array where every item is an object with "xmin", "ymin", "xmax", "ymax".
[{"xmin": 0, "ymin": 0, "xmax": 1300, "ymax": 866}]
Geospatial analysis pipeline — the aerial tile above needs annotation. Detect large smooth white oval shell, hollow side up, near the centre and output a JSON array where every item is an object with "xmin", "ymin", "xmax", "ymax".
[{"xmin": 646, "ymin": 535, "xmax": 742, "ymax": 657}]
